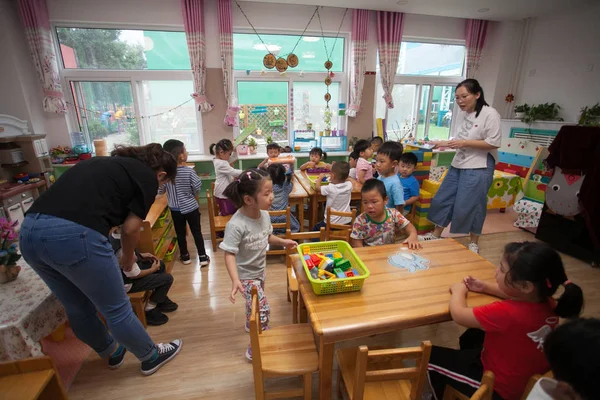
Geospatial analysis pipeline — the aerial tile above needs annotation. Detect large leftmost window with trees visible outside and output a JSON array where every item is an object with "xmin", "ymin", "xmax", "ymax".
[{"xmin": 56, "ymin": 27, "xmax": 204, "ymax": 153}]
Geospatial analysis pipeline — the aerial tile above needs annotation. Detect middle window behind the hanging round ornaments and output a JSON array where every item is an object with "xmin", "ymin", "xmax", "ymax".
[{"xmin": 233, "ymin": 33, "xmax": 347, "ymax": 146}]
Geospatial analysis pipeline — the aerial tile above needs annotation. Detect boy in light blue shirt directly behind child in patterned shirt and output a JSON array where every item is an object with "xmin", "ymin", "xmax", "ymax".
[{"xmin": 375, "ymin": 142, "xmax": 404, "ymax": 212}]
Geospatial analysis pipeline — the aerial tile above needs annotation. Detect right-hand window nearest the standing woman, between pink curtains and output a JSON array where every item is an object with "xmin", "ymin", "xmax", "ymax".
[{"xmin": 376, "ymin": 40, "xmax": 465, "ymax": 140}]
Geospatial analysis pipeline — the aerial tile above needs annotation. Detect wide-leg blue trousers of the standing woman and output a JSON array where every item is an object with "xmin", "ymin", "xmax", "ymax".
[{"xmin": 427, "ymin": 154, "xmax": 496, "ymax": 235}]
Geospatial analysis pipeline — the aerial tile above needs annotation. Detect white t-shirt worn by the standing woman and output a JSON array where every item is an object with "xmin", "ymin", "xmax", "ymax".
[{"xmin": 450, "ymin": 106, "xmax": 502, "ymax": 169}]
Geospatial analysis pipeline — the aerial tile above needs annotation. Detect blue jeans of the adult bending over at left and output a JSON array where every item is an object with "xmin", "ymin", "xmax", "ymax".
[{"xmin": 19, "ymin": 214, "xmax": 156, "ymax": 361}]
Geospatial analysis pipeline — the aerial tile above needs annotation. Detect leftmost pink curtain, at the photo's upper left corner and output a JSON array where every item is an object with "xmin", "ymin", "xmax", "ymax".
[{"xmin": 19, "ymin": 0, "xmax": 67, "ymax": 114}]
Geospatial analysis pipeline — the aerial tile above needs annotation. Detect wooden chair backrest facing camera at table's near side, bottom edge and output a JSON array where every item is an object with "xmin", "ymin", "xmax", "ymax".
[{"xmin": 353, "ymin": 340, "xmax": 431, "ymax": 400}]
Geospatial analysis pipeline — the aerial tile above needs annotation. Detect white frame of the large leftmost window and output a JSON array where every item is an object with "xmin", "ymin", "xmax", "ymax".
[{"xmin": 50, "ymin": 20, "xmax": 204, "ymax": 155}]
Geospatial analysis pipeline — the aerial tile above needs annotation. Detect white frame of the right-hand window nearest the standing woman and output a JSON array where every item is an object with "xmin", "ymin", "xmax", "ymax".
[{"xmin": 373, "ymin": 36, "xmax": 467, "ymax": 138}]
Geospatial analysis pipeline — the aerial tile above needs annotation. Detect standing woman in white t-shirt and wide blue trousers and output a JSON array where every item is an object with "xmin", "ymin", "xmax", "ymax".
[{"xmin": 423, "ymin": 79, "xmax": 502, "ymax": 253}]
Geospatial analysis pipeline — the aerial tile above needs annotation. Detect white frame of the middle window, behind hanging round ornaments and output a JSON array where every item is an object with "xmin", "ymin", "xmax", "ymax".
[{"xmin": 232, "ymin": 27, "xmax": 350, "ymax": 146}]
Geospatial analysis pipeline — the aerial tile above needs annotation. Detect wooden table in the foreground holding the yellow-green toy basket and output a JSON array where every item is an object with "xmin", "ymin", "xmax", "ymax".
[{"xmin": 293, "ymin": 239, "xmax": 497, "ymax": 399}]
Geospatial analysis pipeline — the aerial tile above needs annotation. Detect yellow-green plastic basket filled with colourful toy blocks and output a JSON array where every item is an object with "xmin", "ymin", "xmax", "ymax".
[{"xmin": 298, "ymin": 241, "xmax": 370, "ymax": 294}]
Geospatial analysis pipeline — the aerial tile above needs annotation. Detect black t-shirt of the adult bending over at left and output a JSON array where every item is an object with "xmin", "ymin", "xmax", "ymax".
[{"xmin": 27, "ymin": 157, "xmax": 158, "ymax": 237}]
